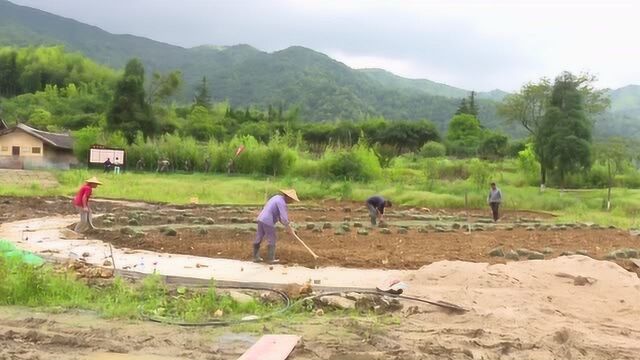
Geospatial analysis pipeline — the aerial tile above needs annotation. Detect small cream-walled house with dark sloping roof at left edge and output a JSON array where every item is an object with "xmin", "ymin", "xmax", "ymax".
[{"xmin": 0, "ymin": 122, "xmax": 78, "ymax": 169}]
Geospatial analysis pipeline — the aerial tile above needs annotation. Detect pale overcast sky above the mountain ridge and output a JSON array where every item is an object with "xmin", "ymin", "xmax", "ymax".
[{"xmin": 10, "ymin": 0, "xmax": 640, "ymax": 91}]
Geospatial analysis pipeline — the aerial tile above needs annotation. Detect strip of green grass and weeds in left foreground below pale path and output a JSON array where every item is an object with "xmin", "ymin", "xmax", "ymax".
[{"xmin": 0, "ymin": 254, "xmax": 281, "ymax": 322}]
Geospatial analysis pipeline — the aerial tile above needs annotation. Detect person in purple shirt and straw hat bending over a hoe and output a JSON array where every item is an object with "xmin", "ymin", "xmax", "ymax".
[{"xmin": 253, "ymin": 189, "xmax": 300, "ymax": 264}]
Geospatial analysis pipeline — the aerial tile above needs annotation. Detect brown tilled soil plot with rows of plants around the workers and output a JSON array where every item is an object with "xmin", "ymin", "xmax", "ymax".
[{"xmin": 80, "ymin": 202, "xmax": 640, "ymax": 269}]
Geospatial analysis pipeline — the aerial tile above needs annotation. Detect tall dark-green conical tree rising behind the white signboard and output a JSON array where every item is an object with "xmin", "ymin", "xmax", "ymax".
[{"xmin": 107, "ymin": 59, "xmax": 157, "ymax": 144}]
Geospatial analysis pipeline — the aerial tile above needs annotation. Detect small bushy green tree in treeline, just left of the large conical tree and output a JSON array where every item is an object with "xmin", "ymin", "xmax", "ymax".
[{"xmin": 447, "ymin": 114, "xmax": 484, "ymax": 156}]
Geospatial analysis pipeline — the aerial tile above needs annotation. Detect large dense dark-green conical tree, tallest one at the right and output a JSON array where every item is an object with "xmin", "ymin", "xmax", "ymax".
[{"xmin": 535, "ymin": 72, "xmax": 593, "ymax": 186}]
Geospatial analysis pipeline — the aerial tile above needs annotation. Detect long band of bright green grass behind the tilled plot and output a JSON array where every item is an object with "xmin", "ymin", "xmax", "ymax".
[{"xmin": 0, "ymin": 169, "xmax": 640, "ymax": 228}]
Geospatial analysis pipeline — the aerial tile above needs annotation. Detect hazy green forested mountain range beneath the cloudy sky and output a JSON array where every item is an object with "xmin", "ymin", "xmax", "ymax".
[{"xmin": 0, "ymin": 0, "xmax": 640, "ymax": 135}]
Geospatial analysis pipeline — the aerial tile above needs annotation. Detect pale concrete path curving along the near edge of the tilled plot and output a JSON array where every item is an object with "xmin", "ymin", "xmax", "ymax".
[{"xmin": 0, "ymin": 216, "xmax": 408, "ymax": 288}]
